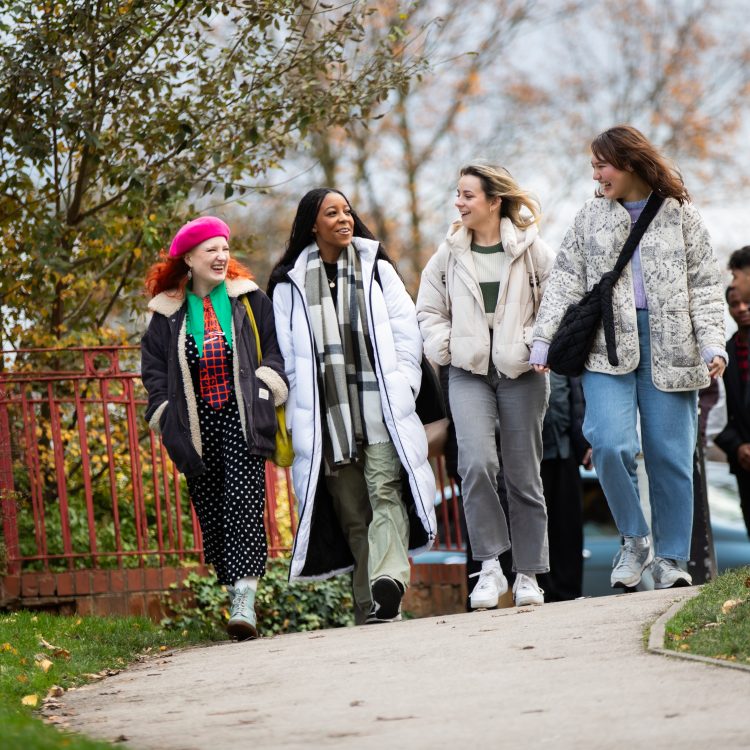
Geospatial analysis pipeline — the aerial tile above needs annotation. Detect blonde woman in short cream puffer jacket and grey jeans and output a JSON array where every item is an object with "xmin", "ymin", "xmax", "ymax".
[{"xmin": 417, "ymin": 165, "xmax": 554, "ymax": 609}]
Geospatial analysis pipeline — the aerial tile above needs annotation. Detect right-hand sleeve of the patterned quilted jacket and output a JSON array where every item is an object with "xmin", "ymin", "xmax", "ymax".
[{"xmin": 682, "ymin": 204, "xmax": 725, "ymax": 352}]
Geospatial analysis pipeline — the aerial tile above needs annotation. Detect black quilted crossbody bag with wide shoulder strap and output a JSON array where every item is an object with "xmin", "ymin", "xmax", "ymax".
[{"xmin": 547, "ymin": 193, "xmax": 664, "ymax": 376}]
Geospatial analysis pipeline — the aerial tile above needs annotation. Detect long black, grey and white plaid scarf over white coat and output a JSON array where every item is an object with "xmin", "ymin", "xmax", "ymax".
[{"xmin": 305, "ymin": 244, "xmax": 390, "ymax": 468}]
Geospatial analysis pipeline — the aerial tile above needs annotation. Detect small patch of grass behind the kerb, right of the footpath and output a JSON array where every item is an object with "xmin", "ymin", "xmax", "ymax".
[{"xmin": 664, "ymin": 567, "xmax": 750, "ymax": 664}]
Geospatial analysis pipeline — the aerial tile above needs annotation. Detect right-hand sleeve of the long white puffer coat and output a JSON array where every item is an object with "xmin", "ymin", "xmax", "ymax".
[{"xmin": 376, "ymin": 260, "xmax": 422, "ymax": 397}]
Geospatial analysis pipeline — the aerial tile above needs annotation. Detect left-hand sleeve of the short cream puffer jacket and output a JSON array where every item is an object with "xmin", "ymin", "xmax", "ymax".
[{"xmin": 417, "ymin": 248, "xmax": 452, "ymax": 366}]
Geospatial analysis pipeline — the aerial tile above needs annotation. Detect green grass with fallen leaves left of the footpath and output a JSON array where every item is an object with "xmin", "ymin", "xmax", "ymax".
[{"xmin": 0, "ymin": 611, "xmax": 212, "ymax": 750}]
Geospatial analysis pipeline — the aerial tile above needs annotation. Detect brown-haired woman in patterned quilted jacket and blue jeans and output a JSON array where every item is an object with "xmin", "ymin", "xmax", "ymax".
[{"xmin": 530, "ymin": 125, "xmax": 727, "ymax": 589}]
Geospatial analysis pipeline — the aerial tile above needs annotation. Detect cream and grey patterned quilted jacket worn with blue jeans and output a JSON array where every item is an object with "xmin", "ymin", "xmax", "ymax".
[{"xmin": 533, "ymin": 198, "xmax": 725, "ymax": 391}]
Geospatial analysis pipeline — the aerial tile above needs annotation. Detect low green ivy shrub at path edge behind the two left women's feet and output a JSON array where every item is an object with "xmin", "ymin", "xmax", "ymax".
[{"xmin": 162, "ymin": 559, "xmax": 354, "ymax": 639}]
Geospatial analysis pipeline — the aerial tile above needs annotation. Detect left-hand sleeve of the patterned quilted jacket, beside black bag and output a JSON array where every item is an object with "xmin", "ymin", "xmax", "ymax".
[{"xmin": 533, "ymin": 207, "xmax": 586, "ymax": 343}]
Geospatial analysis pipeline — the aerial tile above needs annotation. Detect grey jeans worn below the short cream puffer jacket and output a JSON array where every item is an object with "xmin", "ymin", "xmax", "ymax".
[{"xmin": 449, "ymin": 367, "xmax": 549, "ymax": 573}]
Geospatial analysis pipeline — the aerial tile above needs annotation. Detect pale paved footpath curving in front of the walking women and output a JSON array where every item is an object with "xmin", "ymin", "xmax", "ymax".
[{"xmin": 58, "ymin": 589, "xmax": 750, "ymax": 750}]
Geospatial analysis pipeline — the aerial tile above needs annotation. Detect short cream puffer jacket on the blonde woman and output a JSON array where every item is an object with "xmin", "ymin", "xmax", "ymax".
[{"xmin": 417, "ymin": 217, "xmax": 554, "ymax": 378}]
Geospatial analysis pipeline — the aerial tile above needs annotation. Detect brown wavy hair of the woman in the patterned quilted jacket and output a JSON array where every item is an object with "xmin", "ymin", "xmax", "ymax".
[{"xmin": 591, "ymin": 125, "xmax": 690, "ymax": 203}]
